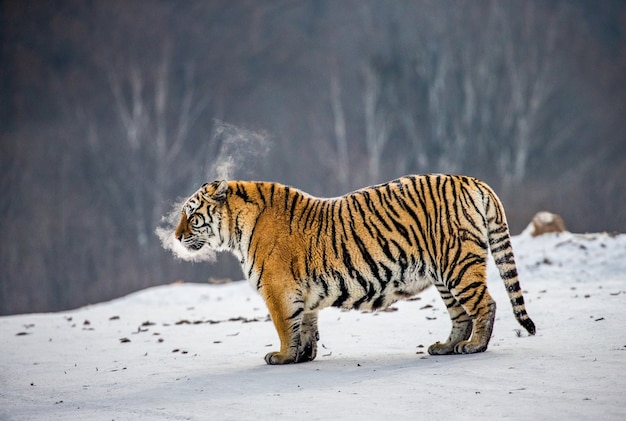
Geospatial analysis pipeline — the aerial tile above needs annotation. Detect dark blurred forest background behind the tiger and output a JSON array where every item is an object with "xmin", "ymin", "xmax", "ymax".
[{"xmin": 0, "ymin": 0, "xmax": 626, "ymax": 314}]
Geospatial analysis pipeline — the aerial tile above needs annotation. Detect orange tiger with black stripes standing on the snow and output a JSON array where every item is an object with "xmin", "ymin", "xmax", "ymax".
[{"xmin": 174, "ymin": 174, "xmax": 535, "ymax": 365}]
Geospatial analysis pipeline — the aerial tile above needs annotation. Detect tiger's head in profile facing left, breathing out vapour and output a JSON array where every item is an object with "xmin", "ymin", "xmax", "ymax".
[{"xmin": 174, "ymin": 180, "xmax": 228, "ymax": 251}]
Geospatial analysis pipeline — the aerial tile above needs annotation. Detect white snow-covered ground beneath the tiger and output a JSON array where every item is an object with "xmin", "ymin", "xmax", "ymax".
[{"xmin": 0, "ymin": 233, "xmax": 626, "ymax": 420}]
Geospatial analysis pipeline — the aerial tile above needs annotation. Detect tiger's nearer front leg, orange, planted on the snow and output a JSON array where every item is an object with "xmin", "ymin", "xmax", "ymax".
[{"xmin": 264, "ymin": 290, "xmax": 304, "ymax": 365}]
